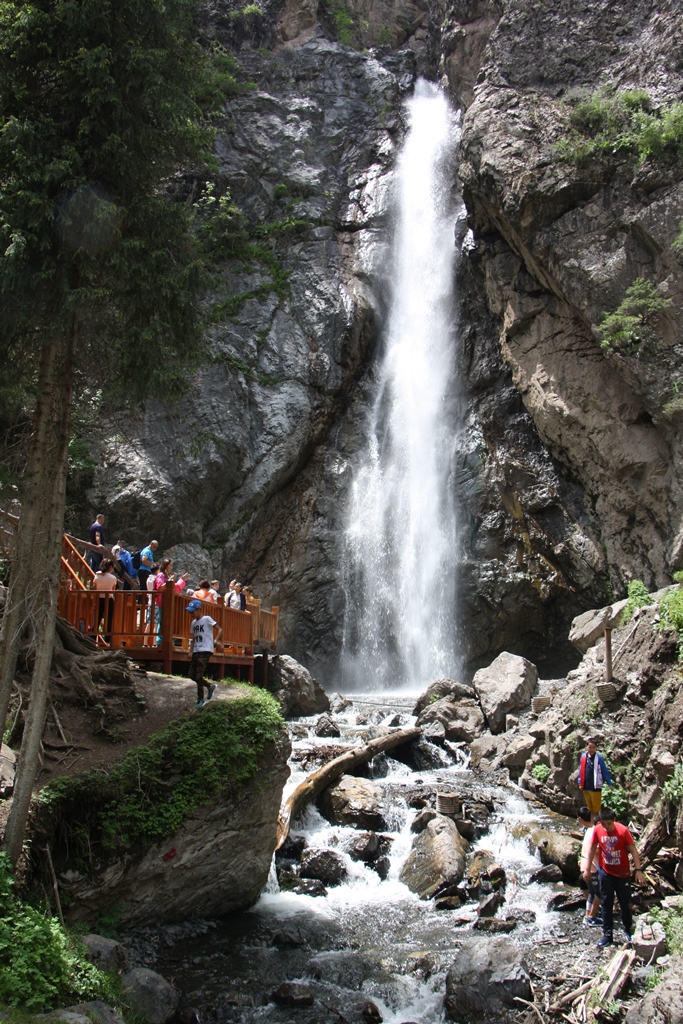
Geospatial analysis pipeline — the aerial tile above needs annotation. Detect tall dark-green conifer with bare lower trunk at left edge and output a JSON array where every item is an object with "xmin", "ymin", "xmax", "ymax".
[{"xmin": 0, "ymin": 0, "xmax": 216, "ymax": 861}]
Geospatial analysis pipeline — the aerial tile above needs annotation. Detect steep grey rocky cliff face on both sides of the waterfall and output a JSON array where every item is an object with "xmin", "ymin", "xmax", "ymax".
[{"xmin": 83, "ymin": 0, "xmax": 683, "ymax": 683}]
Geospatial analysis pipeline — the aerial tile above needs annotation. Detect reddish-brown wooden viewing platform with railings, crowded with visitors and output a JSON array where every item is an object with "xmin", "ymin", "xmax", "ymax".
[{"xmin": 0, "ymin": 510, "xmax": 279, "ymax": 684}]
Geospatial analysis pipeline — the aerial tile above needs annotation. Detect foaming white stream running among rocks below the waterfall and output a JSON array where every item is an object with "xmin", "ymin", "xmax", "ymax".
[{"xmin": 140, "ymin": 694, "xmax": 594, "ymax": 1024}]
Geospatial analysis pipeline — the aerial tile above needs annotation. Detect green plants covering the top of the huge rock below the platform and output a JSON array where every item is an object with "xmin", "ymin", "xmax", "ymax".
[{"xmin": 31, "ymin": 687, "xmax": 283, "ymax": 870}]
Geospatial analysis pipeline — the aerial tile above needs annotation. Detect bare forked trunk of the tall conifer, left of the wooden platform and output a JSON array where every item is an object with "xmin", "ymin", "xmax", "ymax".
[{"xmin": 0, "ymin": 321, "xmax": 77, "ymax": 863}]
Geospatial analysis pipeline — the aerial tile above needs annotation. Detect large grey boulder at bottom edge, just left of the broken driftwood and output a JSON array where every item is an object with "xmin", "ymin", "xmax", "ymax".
[{"xmin": 443, "ymin": 938, "xmax": 531, "ymax": 1022}]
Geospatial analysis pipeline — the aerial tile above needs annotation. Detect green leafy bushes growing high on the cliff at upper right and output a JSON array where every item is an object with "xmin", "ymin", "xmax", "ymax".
[{"xmin": 557, "ymin": 89, "xmax": 683, "ymax": 165}]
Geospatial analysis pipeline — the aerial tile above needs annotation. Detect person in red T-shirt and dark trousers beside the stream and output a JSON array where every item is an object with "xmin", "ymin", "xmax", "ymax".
[{"xmin": 584, "ymin": 807, "xmax": 643, "ymax": 947}]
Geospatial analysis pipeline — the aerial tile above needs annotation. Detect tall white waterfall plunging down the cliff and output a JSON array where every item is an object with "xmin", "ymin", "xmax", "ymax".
[{"xmin": 342, "ymin": 81, "xmax": 459, "ymax": 690}]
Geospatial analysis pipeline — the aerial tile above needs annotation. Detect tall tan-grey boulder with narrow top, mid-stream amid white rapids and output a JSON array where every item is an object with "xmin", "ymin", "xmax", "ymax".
[{"xmin": 400, "ymin": 814, "xmax": 468, "ymax": 899}]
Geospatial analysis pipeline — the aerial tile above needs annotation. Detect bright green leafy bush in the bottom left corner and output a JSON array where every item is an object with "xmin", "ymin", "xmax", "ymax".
[{"xmin": 0, "ymin": 853, "xmax": 115, "ymax": 1013}]
